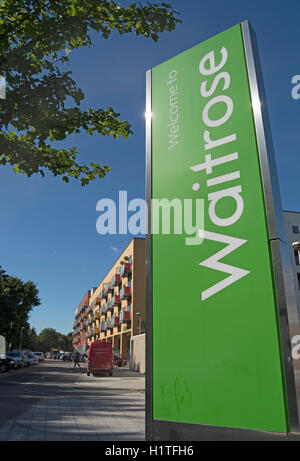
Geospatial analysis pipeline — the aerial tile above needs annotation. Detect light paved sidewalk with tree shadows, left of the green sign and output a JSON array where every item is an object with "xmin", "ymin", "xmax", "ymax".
[{"xmin": 0, "ymin": 369, "xmax": 145, "ymax": 441}]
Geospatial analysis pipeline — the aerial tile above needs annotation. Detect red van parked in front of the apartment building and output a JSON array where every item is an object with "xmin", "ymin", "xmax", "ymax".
[{"xmin": 86, "ymin": 341, "xmax": 113, "ymax": 376}]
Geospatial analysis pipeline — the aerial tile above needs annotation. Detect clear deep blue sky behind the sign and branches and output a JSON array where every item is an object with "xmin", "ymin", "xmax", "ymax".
[{"xmin": 0, "ymin": 0, "xmax": 300, "ymax": 333}]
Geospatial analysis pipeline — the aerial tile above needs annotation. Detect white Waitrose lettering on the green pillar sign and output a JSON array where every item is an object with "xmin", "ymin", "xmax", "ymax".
[{"xmin": 190, "ymin": 47, "xmax": 249, "ymax": 301}]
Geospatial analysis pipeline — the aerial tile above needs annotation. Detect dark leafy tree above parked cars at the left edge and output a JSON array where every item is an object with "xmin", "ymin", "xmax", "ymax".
[{"xmin": 0, "ymin": 266, "xmax": 40, "ymax": 347}]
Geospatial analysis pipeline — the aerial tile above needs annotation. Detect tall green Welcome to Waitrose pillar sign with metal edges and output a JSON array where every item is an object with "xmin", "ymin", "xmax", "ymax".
[{"xmin": 147, "ymin": 22, "xmax": 297, "ymax": 440}]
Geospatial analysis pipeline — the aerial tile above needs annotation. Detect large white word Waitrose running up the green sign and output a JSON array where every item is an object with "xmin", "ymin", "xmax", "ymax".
[{"xmin": 191, "ymin": 46, "xmax": 249, "ymax": 300}]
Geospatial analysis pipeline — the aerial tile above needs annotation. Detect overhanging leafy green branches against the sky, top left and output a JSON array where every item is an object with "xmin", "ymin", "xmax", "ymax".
[{"xmin": 0, "ymin": 0, "xmax": 181, "ymax": 185}]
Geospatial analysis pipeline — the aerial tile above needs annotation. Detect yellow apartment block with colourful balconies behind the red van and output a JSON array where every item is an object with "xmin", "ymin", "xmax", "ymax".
[{"xmin": 74, "ymin": 238, "xmax": 146, "ymax": 361}]
